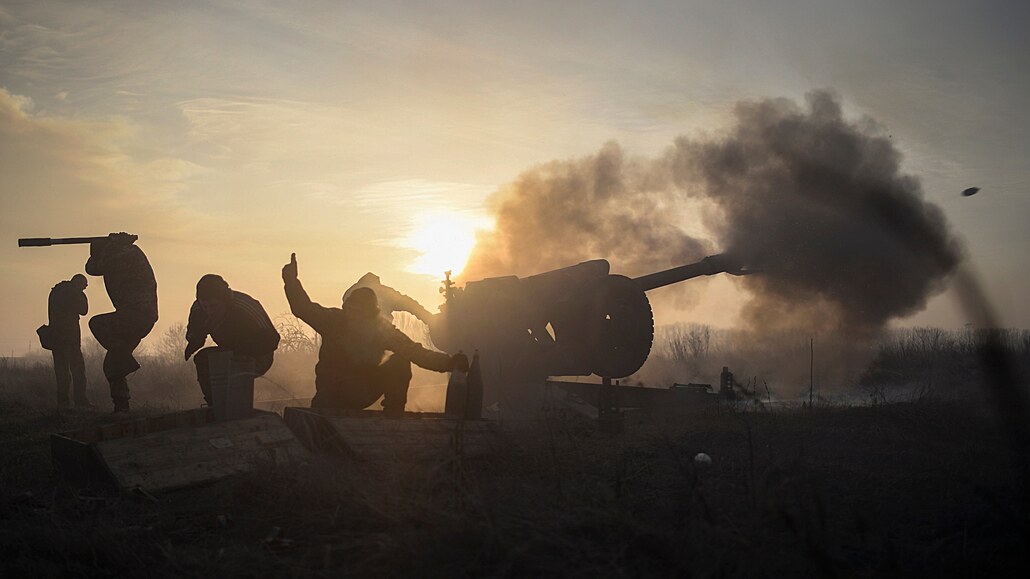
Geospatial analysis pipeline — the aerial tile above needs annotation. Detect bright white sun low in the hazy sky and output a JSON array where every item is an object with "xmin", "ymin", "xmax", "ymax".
[{"xmin": 403, "ymin": 211, "xmax": 492, "ymax": 276}]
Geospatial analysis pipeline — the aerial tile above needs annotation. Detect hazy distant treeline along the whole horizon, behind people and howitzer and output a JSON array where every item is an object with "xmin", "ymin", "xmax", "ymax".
[{"xmin": 0, "ymin": 314, "xmax": 1030, "ymax": 408}]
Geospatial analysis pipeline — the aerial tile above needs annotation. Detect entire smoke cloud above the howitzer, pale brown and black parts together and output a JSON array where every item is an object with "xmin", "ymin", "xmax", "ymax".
[{"xmin": 466, "ymin": 92, "xmax": 962, "ymax": 333}]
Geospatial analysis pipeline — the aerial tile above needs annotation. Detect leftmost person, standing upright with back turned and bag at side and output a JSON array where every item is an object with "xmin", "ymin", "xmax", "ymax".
[{"xmin": 46, "ymin": 273, "xmax": 92, "ymax": 408}]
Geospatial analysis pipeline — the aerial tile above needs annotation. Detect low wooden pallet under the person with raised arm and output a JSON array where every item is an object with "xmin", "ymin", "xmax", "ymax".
[{"xmin": 282, "ymin": 407, "xmax": 504, "ymax": 461}]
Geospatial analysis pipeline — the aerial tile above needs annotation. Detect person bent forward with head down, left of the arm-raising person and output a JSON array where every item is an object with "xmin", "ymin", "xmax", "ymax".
[{"xmin": 185, "ymin": 273, "xmax": 279, "ymax": 406}]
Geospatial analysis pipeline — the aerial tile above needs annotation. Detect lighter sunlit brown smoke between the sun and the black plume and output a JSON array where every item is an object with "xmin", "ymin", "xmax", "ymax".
[{"xmin": 462, "ymin": 142, "xmax": 711, "ymax": 279}]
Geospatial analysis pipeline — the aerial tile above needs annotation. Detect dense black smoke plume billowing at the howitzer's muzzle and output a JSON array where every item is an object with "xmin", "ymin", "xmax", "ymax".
[{"xmin": 667, "ymin": 92, "xmax": 961, "ymax": 331}]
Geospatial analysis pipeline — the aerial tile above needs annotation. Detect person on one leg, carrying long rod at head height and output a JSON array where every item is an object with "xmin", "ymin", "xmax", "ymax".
[{"xmin": 85, "ymin": 233, "xmax": 158, "ymax": 412}]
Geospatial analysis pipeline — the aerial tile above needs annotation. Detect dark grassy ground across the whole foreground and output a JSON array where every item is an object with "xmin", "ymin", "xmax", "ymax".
[{"xmin": 0, "ymin": 395, "xmax": 1028, "ymax": 577}]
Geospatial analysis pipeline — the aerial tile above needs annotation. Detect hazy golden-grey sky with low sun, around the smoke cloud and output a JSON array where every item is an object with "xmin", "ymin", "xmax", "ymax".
[{"xmin": 0, "ymin": 0, "xmax": 1030, "ymax": 353}]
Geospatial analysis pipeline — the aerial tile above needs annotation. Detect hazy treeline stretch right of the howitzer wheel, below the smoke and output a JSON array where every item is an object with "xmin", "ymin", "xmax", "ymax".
[{"xmin": 630, "ymin": 323, "xmax": 1030, "ymax": 400}]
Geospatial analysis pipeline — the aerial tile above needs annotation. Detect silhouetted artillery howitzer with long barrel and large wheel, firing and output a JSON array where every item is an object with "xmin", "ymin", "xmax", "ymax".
[{"xmin": 430, "ymin": 254, "xmax": 751, "ymax": 398}]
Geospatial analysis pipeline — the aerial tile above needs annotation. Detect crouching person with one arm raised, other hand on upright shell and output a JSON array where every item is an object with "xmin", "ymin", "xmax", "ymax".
[{"xmin": 282, "ymin": 253, "xmax": 469, "ymax": 415}]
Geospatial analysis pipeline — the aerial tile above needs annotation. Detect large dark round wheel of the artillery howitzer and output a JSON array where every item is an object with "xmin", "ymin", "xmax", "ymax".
[{"xmin": 590, "ymin": 275, "xmax": 654, "ymax": 378}]
